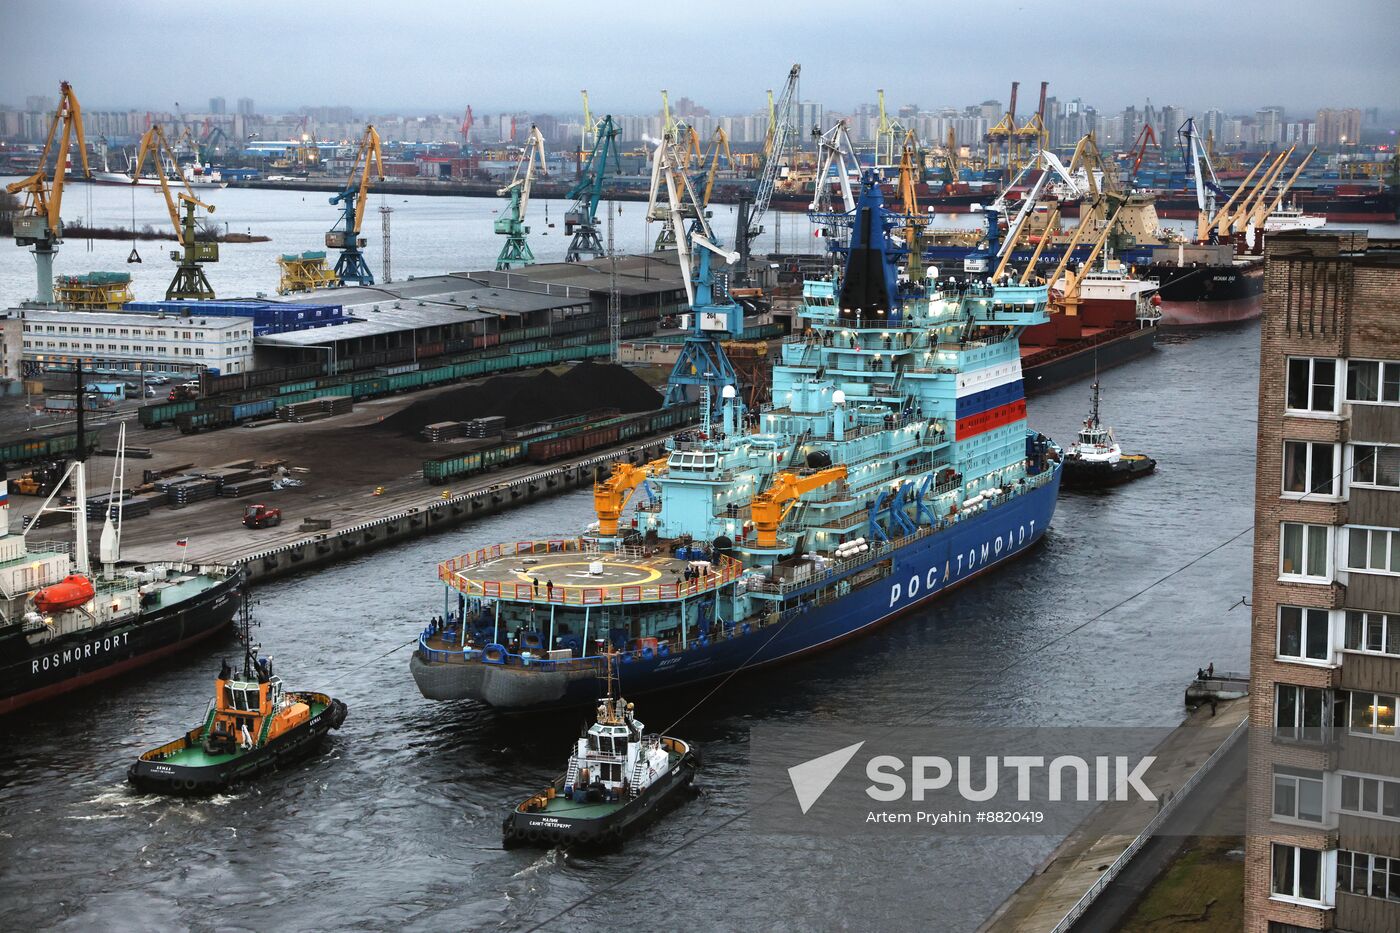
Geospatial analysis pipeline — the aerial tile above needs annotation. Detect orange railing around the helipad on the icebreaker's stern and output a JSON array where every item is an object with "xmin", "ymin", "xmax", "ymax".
[{"xmin": 438, "ymin": 539, "xmax": 743, "ymax": 607}]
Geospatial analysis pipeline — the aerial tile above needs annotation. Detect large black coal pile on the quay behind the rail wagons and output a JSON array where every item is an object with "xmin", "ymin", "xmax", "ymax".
[{"xmin": 377, "ymin": 363, "xmax": 662, "ymax": 438}]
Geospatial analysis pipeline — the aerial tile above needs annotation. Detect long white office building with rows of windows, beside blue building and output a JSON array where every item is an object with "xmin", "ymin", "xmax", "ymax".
[{"xmin": 17, "ymin": 308, "xmax": 253, "ymax": 374}]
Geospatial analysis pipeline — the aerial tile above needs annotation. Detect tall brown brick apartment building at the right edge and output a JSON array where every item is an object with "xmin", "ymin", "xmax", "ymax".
[{"xmin": 1245, "ymin": 231, "xmax": 1400, "ymax": 933}]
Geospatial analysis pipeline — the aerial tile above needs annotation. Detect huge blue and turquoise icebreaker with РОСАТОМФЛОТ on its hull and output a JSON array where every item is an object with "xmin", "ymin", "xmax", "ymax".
[{"xmin": 409, "ymin": 172, "xmax": 1061, "ymax": 710}]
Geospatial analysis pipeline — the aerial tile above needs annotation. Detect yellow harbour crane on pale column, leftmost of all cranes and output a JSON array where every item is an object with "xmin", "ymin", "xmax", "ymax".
[{"xmin": 6, "ymin": 81, "xmax": 92, "ymax": 304}]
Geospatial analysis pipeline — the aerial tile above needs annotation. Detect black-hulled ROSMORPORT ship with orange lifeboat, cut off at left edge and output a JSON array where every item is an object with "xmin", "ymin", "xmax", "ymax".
[{"xmin": 0, "ymin": 377, "xmax": 242, "ymax": 714}]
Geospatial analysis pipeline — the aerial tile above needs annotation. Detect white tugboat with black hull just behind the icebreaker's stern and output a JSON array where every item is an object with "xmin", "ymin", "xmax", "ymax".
[{"xmin": 501, "ymin": 657, "xmax": 700, "ymax": 849}]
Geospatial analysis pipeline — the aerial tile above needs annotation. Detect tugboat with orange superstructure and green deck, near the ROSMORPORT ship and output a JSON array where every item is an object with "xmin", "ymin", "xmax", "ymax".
[{"xmin": 126, "ymin": 600, "xmax": 347, "ymax": 796}]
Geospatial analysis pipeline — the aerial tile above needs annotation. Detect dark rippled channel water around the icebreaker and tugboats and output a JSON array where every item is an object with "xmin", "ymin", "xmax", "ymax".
[{"xmin": 0, "ymin": 318, "xmax": 1259, "ymax": 932}]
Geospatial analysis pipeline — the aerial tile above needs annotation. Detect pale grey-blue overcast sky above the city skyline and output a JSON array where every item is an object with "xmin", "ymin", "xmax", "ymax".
[{"xmin": 0, "ymin": 0, "xmax": 1400, "ymax": 113}]
